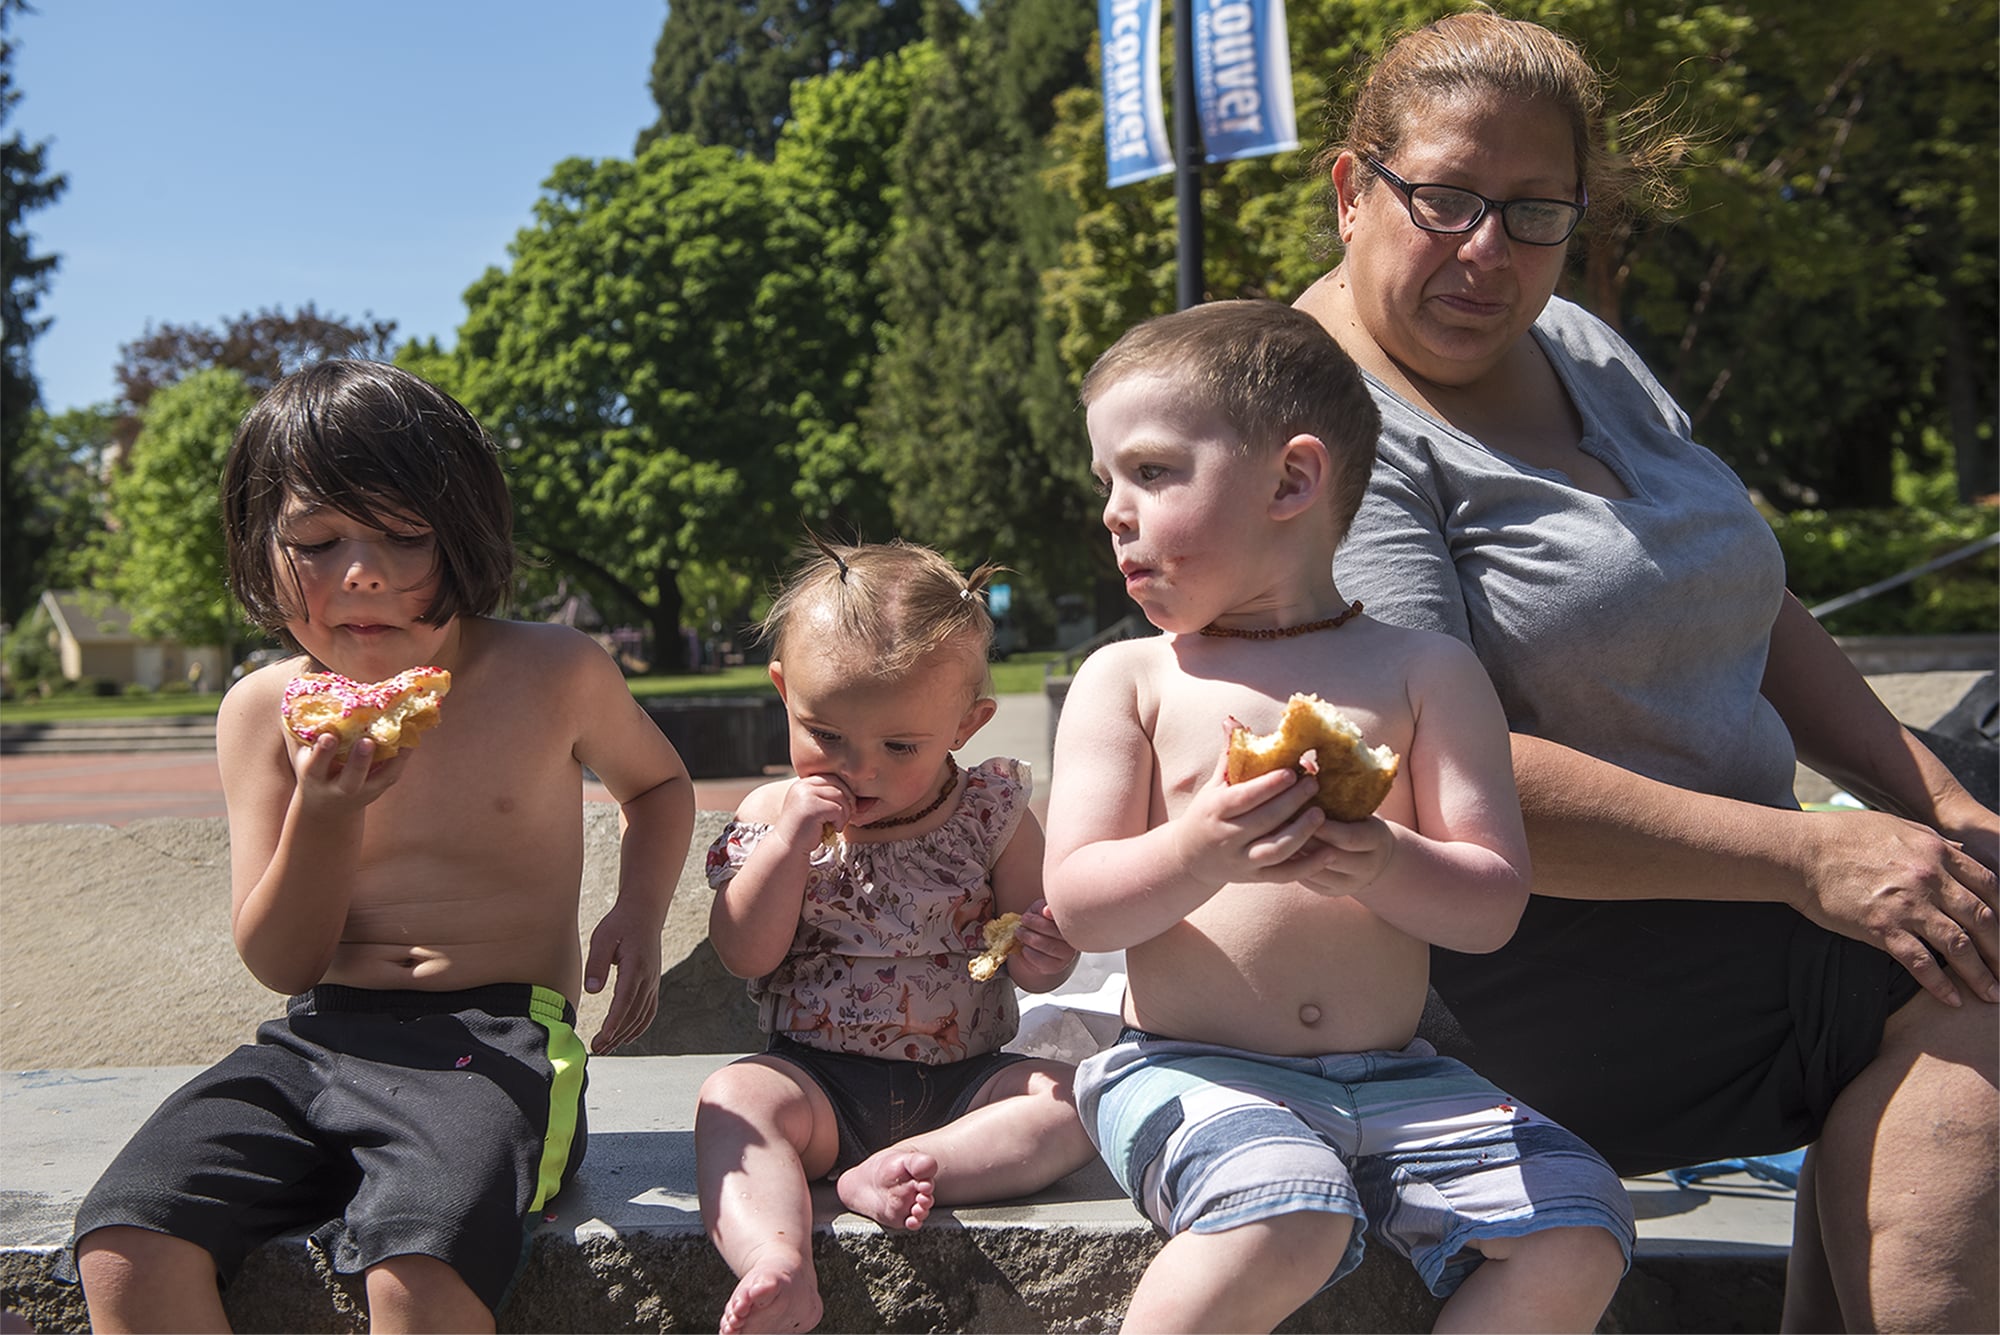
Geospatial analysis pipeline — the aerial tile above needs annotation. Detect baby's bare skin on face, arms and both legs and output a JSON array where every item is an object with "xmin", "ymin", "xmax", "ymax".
[{"xmin": 694, "ymin": 627, "xmax": 1094, "ymax": 1331}]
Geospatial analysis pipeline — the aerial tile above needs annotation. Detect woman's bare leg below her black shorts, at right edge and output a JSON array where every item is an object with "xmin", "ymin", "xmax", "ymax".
[{"xmin": 1786, "ymin": 991, "xmax": 2000, "ymax": 1331}]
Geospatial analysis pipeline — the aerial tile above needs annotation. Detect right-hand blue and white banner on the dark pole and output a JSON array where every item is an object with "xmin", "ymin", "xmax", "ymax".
[{"xmin": 1184, "ymin": 0, "xmax": 1298, "ymax": 165}]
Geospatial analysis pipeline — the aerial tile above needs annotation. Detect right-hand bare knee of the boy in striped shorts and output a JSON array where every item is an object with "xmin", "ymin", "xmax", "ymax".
[{"xmin": 1432, "ymin": 1227, "xmax": 1624, "ymax": 1331}]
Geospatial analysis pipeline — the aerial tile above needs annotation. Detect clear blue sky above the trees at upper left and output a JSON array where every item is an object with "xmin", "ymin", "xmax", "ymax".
[{"xmin": 6, "ymin": 0, "xmax": 666, "ymax": 412}]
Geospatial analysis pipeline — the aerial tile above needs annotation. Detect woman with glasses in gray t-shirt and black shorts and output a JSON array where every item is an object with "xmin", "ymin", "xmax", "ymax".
[{"xmin": 1298, "ymin": 12, "xmax": 2000, "ymax": 1331}]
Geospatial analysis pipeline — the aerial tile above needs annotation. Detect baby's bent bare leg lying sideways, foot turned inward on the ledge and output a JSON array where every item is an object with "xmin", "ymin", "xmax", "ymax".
[{"xmin": 838, "ymin": 1061, "xmax": 1096, "ymax": 1229}]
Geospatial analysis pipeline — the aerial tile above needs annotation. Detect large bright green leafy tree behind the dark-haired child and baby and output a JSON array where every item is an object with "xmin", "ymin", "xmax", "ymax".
[{"xmin": 458, "ymin": 56, "xmax": 932, "ymax": 668}]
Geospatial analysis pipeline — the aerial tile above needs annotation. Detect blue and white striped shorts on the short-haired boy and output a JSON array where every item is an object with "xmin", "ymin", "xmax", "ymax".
[{"xmin": 1076, "ymin": 1029, "xmax": 1634, "ymax": 1297}]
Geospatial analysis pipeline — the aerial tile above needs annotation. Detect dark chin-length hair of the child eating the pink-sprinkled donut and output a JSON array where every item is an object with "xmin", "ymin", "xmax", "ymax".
[{"xmin": 222, "ymin": 358, "xmax": 514, "ymax": 648}]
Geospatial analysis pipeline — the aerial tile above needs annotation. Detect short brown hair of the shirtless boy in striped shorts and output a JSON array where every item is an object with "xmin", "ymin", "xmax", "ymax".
[{"xmin": 1078, "ymin": 300, "xmax": 1382, "ymax": 538}]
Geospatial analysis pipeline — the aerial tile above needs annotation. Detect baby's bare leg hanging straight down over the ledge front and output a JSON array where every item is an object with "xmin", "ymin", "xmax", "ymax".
[{"xmin": 694, "ymin": 1057, "xmax": 838, "ymax": 1335}]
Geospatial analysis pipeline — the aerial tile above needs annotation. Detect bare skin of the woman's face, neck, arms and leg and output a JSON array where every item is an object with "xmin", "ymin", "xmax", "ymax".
[{"xmin": 1298, "ymin": 67, "xmax": 2000, "ymax": 1329}]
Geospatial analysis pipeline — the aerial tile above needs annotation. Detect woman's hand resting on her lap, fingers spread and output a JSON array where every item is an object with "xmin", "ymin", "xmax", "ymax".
[{"xmin": 1798, "ymin": 811, "xmax": 2000, "ymax": 1005}]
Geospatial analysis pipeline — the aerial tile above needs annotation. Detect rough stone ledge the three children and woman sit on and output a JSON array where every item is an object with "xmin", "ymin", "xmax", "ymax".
[{"xmin": 0, "ymin": 1055, "xmax": 1792, "ymax": 1331}]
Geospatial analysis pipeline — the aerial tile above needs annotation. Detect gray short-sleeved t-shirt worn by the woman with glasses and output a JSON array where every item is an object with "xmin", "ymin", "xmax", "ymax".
[{"xmin": 1336, "ymin": 298, "xmax": 1796, "ymax": 805}]
